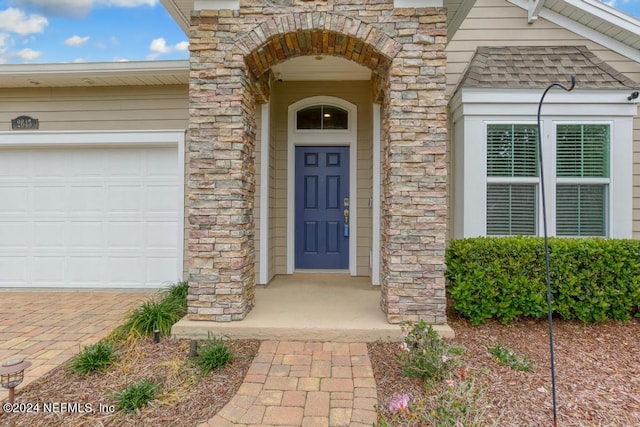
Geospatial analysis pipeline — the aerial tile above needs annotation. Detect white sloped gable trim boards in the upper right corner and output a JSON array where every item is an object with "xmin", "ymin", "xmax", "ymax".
[{"xmin": 507, "ymin": 0, "xmax": 640, "ymax": 63}]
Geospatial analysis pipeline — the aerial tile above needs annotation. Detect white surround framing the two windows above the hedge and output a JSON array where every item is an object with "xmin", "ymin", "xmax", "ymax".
[{"xmin": 450, "ymin": 88, "xmax": 637, "ymax": 238}]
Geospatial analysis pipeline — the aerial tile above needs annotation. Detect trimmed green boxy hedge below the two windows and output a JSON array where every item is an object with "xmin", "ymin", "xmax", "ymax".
[{"xmin": 446, "ymin": 237, "xmax": 640, "ymax": 324}]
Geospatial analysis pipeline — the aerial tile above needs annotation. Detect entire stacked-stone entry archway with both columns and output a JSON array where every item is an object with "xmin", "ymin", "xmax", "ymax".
[{"xmin": 186, "ymin": 0, "xmax": 447, "ymax": 323}]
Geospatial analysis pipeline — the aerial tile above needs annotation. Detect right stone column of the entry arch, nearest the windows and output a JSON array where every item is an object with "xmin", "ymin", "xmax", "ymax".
[{"xmin": 381, "ymin": 8, "xmax": 447, "ymax": 324}]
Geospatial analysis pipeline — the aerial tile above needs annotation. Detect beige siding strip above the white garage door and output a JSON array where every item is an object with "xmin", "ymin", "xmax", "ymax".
[{"xmin": 0, "ymin": 85, "xmax": 189, "ymax": 131}]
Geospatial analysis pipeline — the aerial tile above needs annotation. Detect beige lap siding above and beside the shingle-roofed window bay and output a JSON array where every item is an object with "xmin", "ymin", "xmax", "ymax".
[{"xmin": 447, "ymin": 0, "xmax": 640, "ymax": 239}]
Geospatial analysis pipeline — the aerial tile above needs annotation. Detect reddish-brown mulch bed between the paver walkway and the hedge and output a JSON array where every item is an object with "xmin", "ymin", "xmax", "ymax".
[{"xmin": 369, "ymin": 318, "xmax": 640, "ymax": 426}]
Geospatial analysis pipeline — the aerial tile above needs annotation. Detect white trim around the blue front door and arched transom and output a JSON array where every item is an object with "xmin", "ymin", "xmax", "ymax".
[{"xmin": 287, "ymin": 96, "xmax": 358, "ymax": 276}]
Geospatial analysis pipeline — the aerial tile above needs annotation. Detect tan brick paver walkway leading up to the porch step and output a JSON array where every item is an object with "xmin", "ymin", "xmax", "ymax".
[{"xmin": 199, "ymin": 341, "xmax": 377, "ymax": 427}]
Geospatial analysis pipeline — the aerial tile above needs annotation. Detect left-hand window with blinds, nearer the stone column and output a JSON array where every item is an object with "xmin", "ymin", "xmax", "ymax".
[{"xmin": 486, "ymin": 124, "xmax": 538, "ymax": 236}]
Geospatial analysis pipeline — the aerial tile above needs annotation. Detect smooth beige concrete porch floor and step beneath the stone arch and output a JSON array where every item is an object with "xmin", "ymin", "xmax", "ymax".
[{"xmin": 171, "ymin": 273, "xmax": 454, "ymax": 342}]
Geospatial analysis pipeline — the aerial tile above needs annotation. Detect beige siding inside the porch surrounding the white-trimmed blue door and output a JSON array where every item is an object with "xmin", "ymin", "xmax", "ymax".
[{"xmin": 270, "ymin": 81, "xmax": 373, "ymax": 276}]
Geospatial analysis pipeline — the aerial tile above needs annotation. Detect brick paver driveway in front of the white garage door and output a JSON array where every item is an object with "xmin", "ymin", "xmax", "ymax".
[{"xmin": 0, "ymin": 289, "xmax": 153, "ymax": 400}]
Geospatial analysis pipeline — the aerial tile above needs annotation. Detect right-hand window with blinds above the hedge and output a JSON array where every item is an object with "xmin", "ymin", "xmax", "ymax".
[{"xmin": 556, "ymin": 124, "xmax": 610, "ymax": 237}]
